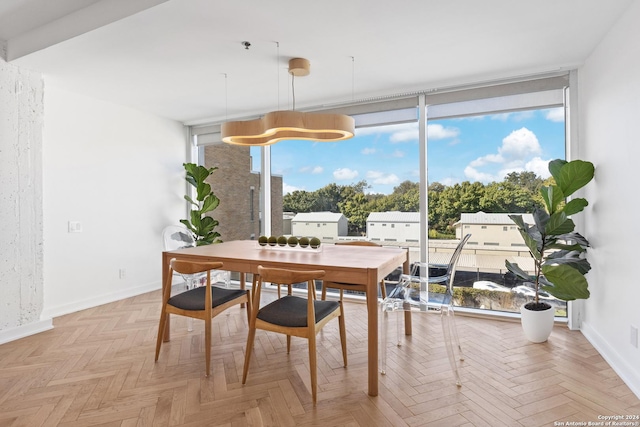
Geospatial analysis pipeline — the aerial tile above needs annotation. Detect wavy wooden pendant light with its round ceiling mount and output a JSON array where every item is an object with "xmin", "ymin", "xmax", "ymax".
[{"xmin": 221, "ymin": 58, "xmax": 355, "ymax": 145}]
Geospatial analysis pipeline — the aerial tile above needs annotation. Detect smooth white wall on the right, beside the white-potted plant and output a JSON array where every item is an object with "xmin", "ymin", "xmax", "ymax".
[{"xmin": 577, "ymin": 2, "xmax": 640, "ymax": 397}]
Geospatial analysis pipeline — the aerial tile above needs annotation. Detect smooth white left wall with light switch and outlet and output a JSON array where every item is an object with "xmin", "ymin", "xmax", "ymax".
[{"xmin": 43, "ymin": 81, "xmax": 186, "ymax": 317}]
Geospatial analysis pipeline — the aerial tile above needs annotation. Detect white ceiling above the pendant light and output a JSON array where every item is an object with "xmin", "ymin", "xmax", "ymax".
[{"xmin": 0, "ymin": 0, "xmax": 633, "ymax": 124}]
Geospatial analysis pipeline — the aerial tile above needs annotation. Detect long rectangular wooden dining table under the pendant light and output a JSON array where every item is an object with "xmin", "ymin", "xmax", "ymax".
[{"xmin": 162, "ymin": 240, "xmax": 408, "ymax": 396}]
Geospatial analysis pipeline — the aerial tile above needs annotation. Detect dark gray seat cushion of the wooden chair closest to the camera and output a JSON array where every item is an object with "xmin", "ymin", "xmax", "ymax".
[{"xmin": 258, "ymin": 295, "xmax": 340, "ymax": 328}]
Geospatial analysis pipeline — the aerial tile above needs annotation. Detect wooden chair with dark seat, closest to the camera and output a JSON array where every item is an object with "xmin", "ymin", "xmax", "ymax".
[{"xmin": 242, "ymin": 266, "xmax": 347, "ymax": 405}]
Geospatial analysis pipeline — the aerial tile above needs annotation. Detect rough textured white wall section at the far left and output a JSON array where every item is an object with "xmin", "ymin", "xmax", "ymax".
[{"xmin": 0, "ymin": 59, "xmax": 43, "ymax": 332}]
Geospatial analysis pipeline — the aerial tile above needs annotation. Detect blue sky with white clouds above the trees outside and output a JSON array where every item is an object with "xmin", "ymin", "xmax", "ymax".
[{"xmin": 252, "ymin": 108, "xmax": 565, "ymax": 194}]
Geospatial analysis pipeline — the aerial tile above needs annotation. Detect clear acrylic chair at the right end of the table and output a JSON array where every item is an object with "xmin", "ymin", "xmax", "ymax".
[{"xmin": 380, "ymin": 234, "xmax": 471, "ymax": 387}]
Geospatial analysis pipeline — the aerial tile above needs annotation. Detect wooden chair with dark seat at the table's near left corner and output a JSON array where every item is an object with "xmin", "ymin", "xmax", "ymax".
[{"xmin": 155, "ymin": 258, "xmax": 251, "ymax": 376}]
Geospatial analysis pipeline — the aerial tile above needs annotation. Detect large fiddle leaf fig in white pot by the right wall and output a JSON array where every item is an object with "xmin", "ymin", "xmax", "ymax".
[{"xmin": 505, "ymin": 159, "xmax": 594, "ymax": 342}]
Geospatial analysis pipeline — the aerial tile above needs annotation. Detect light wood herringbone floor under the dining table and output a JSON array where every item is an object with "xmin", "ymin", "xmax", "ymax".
[{"xmin": 0, "ymin": 292, "xmax": 640, "ymax": 427}]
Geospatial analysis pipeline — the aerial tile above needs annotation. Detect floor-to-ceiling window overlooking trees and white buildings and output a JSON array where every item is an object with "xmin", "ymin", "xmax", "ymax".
[{"xmin": 194, "ymin": 75, "xmax": 568, "ymax": 315}]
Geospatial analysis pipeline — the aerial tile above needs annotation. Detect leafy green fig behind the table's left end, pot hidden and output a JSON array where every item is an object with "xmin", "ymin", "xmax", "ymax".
[{"xmin": 180, "ymin": 163, "xmax": 222, "ymax": 246}]
